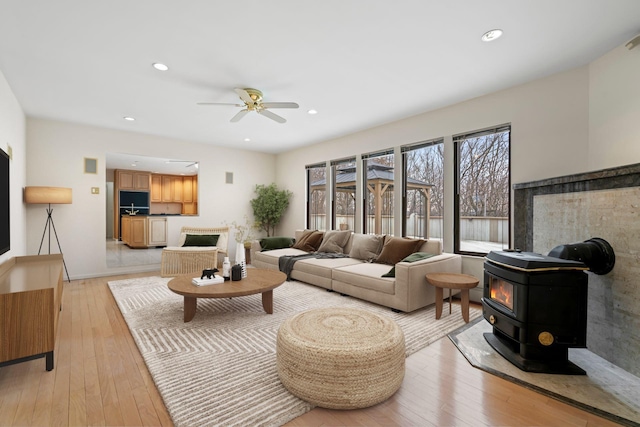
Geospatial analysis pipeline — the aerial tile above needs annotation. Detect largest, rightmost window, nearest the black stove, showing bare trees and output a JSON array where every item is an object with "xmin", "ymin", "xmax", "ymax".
[{"xmin": 453, "ymin": 125, "xmax": 511, "ymax": 255}]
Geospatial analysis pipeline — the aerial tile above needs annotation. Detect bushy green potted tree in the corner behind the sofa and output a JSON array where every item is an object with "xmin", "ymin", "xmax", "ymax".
[{"xmin": 250, "ymin": 183, "xmax": 293, "ymax": 237}]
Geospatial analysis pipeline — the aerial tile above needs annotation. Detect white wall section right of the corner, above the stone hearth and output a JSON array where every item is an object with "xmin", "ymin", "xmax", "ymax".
[{"xmin": 589, "ymin": 46, "xmax": 640, "ymax": 170}]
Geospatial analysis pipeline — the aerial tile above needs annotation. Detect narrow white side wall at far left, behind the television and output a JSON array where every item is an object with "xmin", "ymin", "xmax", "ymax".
[{"xmin": 0, "ymin": 71, "xmax": 27, "ymax": 263}]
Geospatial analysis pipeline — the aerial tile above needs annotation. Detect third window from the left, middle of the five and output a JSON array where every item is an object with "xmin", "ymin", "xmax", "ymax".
[{"xmin": 362, "ymin": 151, "xmax": 394, "ymax": 235}]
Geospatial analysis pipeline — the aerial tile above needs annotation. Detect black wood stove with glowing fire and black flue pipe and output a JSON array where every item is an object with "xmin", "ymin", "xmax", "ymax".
[{"xmin": 482, "ymin": 238, "xmax": 615, "ymax": 375}]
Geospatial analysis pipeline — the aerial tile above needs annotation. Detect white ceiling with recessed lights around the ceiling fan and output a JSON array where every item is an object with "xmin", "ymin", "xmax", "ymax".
[{"xmin": 0, "ymin": 0, "xmax": 640, "ymax": 159}]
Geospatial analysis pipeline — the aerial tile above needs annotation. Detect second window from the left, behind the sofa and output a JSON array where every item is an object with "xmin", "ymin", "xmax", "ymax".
[{"xmin": 331, "ymin": 158, "xmax": 356, "ymax": 230}]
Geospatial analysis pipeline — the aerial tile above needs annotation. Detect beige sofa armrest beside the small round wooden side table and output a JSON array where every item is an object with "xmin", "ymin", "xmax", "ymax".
[{"xmin": 396, "ymin": 253, "xmax": 462, "ymax": 311}]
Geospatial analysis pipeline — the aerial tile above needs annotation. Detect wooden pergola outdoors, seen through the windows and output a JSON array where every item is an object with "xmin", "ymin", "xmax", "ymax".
[{"xmin": 310, "ymin": 162, "xmax": 433, "ymax": 236}]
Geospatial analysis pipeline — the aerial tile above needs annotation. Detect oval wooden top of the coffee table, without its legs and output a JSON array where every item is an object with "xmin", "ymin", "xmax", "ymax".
[{"xmin": 168, "ymin": 268, "xmax": 287, "ymax": 298}]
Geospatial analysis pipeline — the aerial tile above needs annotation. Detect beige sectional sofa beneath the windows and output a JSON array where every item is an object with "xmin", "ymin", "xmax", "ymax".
[{"xmin": 251, "ymin": 230, "xmax": 462, "ymax": 312}]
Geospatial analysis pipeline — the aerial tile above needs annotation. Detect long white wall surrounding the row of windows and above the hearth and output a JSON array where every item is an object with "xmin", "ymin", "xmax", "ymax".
[{"xmin": 277, "ymin": 41, "xmax": 640, "ymax": 284}]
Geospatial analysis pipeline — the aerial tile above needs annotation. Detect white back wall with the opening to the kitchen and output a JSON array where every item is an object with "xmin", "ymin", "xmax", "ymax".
[{"xmin": 26, "ymin": 118, "xmax": 275, "ymax": 279}]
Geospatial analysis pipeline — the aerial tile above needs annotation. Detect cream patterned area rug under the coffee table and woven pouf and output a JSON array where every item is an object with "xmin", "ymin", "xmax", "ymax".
[{"xmin": 109, "ymin": 277, "xmax": 481, "ymax": 426}]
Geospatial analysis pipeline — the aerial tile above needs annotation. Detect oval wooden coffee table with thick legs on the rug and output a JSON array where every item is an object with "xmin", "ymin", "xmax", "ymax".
[{"xmin": 168, "ymin": 268, "xmax": 287, "ymax": 323}]
